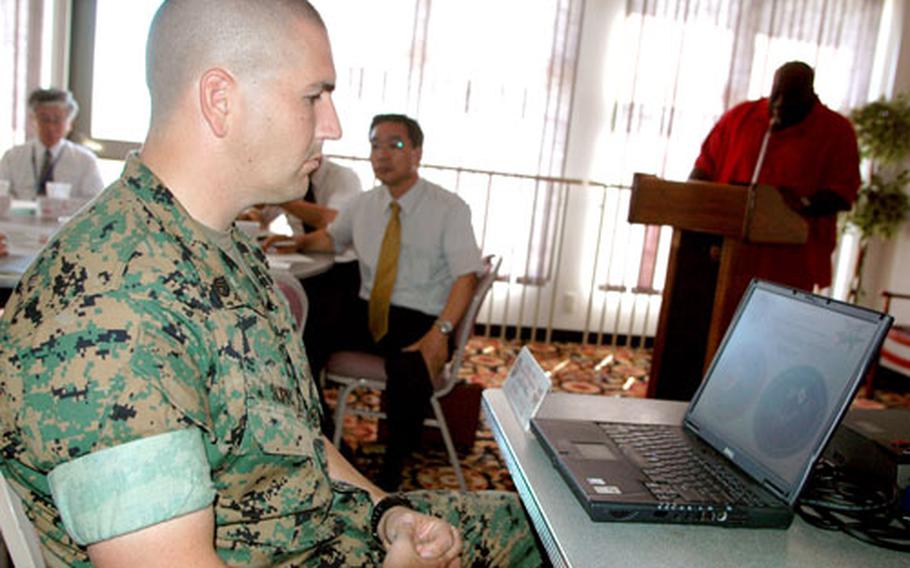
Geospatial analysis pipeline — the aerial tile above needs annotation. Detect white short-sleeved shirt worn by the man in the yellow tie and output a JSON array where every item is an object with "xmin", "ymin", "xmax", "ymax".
[{"xmin": 328, "ymin": 178, "xmax": 482, "ymax": 315}]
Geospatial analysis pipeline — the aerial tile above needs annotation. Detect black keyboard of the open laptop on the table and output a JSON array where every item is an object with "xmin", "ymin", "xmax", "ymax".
[{"xmin": 600, "ymin": 422, "xmax": 768, "ymax": 507}]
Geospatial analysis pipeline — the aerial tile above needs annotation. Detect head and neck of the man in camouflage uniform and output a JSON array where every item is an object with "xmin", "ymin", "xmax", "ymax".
[{"xmin": 139, "ymin": 0, "xmax": 341, "ymax": 230}]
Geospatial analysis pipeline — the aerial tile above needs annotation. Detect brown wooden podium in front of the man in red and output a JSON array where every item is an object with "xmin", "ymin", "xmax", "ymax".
[{"xmin": 629, "ymin": 174, "xmax": 808, "ymax": 400}]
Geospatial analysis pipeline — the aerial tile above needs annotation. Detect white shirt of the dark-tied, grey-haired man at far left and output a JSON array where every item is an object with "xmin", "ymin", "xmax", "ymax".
[{"xmin": 0, "ymin": 139, "xmax": 104, "ymax": 200}]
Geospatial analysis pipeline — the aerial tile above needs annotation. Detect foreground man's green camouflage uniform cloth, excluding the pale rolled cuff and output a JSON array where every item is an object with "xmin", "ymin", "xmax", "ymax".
[{"xmin": 0, "ymin": 156, "xmax": 537, "ymax": 566}]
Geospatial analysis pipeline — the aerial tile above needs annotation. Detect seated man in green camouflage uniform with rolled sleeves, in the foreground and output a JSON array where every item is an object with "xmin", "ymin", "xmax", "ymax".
[{"xmin": 0, "ymin": 0, "xmax": 540, "ymax": 567}]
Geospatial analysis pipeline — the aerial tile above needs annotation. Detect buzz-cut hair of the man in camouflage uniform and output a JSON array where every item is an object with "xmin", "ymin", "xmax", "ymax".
[{"xmin": 146, "ymin": 0, "xmax": 325, "ymax": 126}]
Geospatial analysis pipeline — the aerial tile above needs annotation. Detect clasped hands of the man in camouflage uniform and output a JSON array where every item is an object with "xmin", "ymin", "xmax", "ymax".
[{"xmin": 380, "ymin": 507, "xmax": 461, "ymax": 568}]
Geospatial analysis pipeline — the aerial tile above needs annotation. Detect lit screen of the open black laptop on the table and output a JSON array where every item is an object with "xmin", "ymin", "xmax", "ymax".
[{"xmin": 686, "ymin": 281, "xmax": 890, "ymax": 503}]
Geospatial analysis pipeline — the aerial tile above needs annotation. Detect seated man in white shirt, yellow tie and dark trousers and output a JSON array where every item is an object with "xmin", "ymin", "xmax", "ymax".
[{"xmin": 295, "ymin": 114, "xmax": 482, "ymax": 491}]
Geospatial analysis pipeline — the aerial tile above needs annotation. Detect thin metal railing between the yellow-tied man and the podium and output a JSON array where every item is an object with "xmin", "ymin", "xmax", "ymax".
[{"xmin": 331, "ymin": 156, "xmax": 670, "ymax": 347}]
